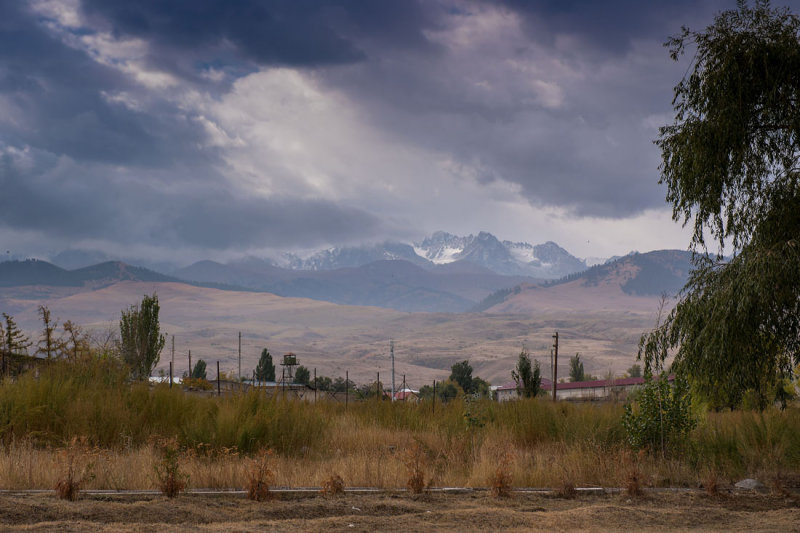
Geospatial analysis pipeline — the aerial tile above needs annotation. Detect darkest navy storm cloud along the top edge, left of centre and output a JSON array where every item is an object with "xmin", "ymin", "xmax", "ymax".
[{"xmin": 82, "ymin": 0, "xmax": 440, "ymax": 77}]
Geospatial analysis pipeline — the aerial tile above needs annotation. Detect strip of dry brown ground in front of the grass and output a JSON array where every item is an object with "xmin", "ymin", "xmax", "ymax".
[{"xmin": 0, "ymin": 492, "xmax": 800, "ymax": 532}]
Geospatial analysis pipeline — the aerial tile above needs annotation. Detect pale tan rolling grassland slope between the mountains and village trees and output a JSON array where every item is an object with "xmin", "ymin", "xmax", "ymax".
[{"xmin": 0, "ymin": 282, "xmax": 658, "ymax": 389}]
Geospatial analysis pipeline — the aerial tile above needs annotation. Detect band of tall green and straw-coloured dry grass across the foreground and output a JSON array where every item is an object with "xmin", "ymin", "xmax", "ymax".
[{"xmin": 0, "ymin": 359, "xmax": 800, "ymax": 489}]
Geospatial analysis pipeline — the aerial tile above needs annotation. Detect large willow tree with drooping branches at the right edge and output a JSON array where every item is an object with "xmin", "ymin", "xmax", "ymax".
[{"xmin": 639, "ymin": 1, "xmax": 800, "ymax": 407}]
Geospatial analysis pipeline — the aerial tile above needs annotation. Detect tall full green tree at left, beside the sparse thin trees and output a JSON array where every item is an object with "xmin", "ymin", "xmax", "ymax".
[{"xmin": 119, "ymin": 293, "xmax": 166, "ymax": 380}]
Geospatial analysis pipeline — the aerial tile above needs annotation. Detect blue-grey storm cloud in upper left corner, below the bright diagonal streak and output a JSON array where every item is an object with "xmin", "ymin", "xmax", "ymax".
[{"xmin": 0, "ymin": 0, "xmax": 209, "ymax": 166}]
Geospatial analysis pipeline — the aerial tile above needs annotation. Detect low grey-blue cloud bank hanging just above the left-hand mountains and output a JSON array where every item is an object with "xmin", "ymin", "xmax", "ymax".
[{"xmin": 0, "ymin": 150, "xmax": 382, "ymax": 251}]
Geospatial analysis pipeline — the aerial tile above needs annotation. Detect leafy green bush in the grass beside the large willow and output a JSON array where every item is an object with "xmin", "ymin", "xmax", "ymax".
[{"xmin": 622, "ymin": 374, "xmax": 697, "ymax": 456}]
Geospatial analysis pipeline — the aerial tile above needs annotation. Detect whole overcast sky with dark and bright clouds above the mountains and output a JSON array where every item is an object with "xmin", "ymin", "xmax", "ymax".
[{"xmin": 0, "ymin": 0, "xmax": 768, "ymax": 263}]
